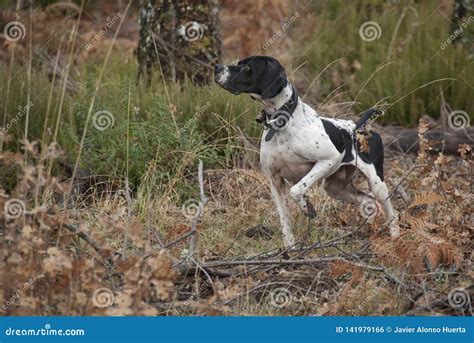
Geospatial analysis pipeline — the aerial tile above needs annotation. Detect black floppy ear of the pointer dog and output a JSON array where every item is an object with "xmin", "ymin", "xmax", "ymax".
[{"xmin": 258, "ymin": 57, "xmax": 288, "ymax": 100}]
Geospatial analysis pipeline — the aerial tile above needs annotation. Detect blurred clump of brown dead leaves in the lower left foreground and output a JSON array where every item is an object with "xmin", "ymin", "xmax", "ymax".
[{"xmin": 0, "ymin": 142, "xmax": 176, "ymax": 315}]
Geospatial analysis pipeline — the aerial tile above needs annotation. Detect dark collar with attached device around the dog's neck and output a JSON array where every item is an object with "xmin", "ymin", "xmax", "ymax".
[{"xmin": 256, "ymin": 86, "xmax": 298, "ymax": 142}]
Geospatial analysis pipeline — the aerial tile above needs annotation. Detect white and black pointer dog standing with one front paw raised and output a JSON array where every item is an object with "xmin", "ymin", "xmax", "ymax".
[{"xmin": 214, "ymin": 56, "xmax": 400, "ymax": 247}]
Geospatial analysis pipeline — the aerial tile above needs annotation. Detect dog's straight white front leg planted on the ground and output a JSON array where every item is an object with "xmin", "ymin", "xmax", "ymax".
[{"xmin": 269, "ymin": 175, "xmax": 295, "ymax": 248}]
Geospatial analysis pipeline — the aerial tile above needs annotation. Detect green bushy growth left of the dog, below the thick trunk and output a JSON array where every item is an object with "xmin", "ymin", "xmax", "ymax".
[{"xmin": 0, "ymin": 57, "xmax": 260, "ymax": 195}]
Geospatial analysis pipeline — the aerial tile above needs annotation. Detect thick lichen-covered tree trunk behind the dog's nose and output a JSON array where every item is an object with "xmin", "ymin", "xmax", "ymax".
[{"xmin": 137, "ymin": 0, "xmax": 221, "ymax": 85}]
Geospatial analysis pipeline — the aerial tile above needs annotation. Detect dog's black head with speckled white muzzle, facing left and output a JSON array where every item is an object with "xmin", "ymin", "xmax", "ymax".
[{"xmin": 214, "ymin": 56, "xmax": 288, "ymax": 100}]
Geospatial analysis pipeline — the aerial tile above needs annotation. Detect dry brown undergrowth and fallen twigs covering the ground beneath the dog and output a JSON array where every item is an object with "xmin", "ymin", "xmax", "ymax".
[{"xmin": 0, "ymin": 118, "xmax": 474, "ymax": 315}]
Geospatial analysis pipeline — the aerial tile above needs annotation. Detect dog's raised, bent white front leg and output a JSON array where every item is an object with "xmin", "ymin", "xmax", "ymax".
[{"xmin": 290, "ymin": 160, "xmax": 338, "ymax": 217}]
